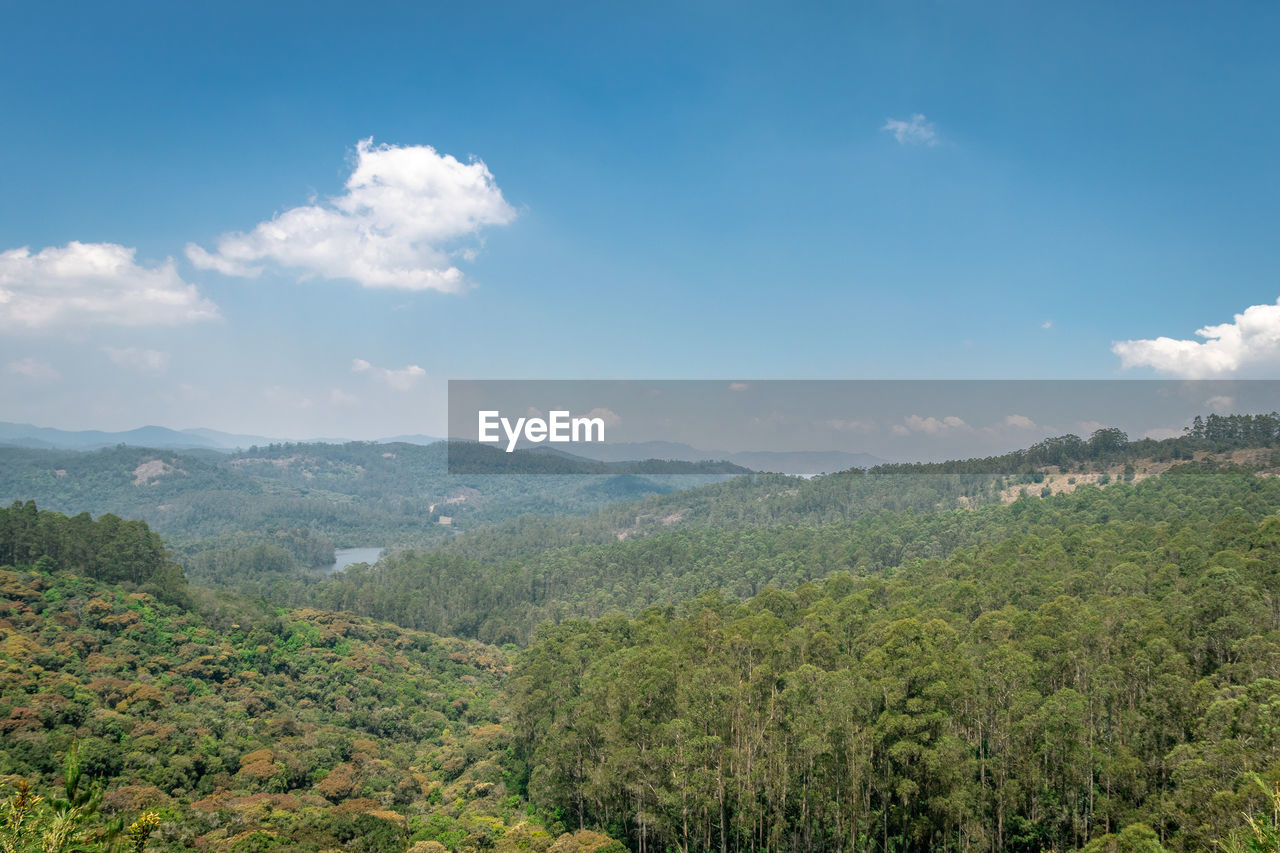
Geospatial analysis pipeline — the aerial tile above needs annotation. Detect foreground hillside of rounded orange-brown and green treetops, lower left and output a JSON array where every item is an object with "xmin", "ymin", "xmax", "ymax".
[{"xmin": 0, "ymin": 503, "xmax": 608, "ymax": 852}]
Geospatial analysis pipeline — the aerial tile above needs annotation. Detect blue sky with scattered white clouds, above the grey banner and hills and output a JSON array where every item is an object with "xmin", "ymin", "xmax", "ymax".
[{"xmin": 0, "ymin": 0, "xmax": 1280, "ymax": 438}]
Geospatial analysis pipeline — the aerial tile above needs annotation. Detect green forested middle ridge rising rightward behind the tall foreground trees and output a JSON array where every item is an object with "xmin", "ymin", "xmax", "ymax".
[{"xmin": 302, "ymin": 464, "xmax": 1280, "ymax": 643}]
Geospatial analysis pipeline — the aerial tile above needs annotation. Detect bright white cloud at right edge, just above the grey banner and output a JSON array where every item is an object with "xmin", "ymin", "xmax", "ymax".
[{"xmin": 1111, "ymin": 301, "xmax": 1280, "ymax": 379}]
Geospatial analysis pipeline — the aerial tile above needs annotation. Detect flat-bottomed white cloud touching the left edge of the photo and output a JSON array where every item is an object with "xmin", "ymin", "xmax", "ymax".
[{"xmin": 0, "ymin": 241, "xmax": 219, "ymax": 332}]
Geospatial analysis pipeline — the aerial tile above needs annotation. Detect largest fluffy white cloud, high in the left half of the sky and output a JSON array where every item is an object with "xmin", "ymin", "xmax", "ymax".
[{"xmin": 187, "ymin": 138, "xmax": 516, "ymax": 292}]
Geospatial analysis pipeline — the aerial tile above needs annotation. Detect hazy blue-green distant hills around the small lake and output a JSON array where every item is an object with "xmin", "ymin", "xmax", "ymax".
[{"xmin": 0, "ymin": 442, "xmax": 723, "ymax": 588}]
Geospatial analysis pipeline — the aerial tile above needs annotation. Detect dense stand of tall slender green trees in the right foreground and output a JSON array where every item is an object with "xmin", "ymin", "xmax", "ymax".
[{"xmin": 508, "ymin": 471, "xmax": 1280, "ymax": 850}]
